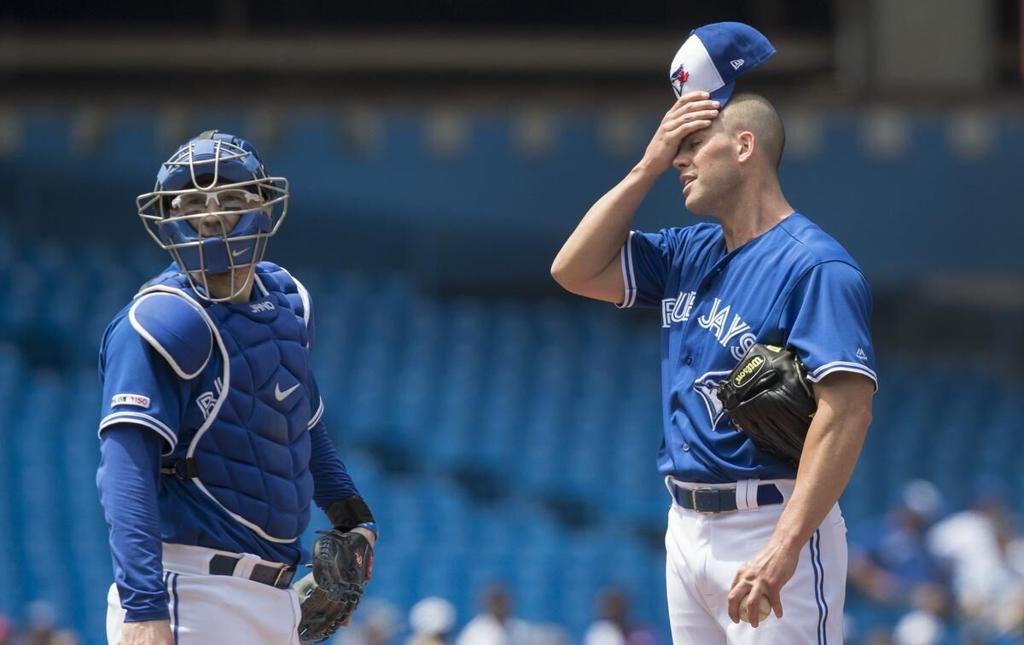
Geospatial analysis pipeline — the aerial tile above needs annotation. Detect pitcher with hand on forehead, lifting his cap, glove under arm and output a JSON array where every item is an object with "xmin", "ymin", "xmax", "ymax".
[{"xmin": 551, "ymin": 23, "xmax": 876, "ymax": 645}]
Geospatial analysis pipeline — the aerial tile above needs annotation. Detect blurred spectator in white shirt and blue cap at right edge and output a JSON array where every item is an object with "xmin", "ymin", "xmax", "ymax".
[{"xmin": 929, "ymin": 479, "xmax": 1024, "ymax": 642}]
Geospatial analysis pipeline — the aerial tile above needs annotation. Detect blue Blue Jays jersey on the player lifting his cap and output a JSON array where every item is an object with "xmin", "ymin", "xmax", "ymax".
[{"xmin": 620, "ymin": 213, "xmax": 877, "ymax": 483}]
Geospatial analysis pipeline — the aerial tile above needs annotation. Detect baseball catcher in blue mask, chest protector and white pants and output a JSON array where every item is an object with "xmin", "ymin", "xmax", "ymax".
[{"xmin": 96, "ymin": 130, "xmax": 377, "ymax": 645}]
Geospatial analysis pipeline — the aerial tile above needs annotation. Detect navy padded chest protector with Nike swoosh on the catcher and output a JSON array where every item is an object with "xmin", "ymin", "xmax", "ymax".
[{"xmin": 136, "ymin": 262, "xmax": 323, "ymax": 543}]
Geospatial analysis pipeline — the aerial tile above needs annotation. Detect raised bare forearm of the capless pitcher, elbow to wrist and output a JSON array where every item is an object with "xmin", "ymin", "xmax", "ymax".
[{"xmin": 551, "ymin": 162, "xmax": 659, "ymax": 288}]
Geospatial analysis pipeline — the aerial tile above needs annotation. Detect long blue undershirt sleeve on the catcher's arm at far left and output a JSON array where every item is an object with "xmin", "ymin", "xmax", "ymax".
[{"xmin": 96, "ymin": 423, "xmax": 168, "ymax": 622}]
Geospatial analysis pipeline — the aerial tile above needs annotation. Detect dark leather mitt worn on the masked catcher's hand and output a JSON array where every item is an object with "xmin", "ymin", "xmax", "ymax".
[{"xmin": 295, "ymin": 530, "xmax": 374, "ymax": 641}]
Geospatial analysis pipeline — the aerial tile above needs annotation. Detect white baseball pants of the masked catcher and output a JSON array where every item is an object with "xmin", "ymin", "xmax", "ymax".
[{"xmin": 106, "ymin": 545, "xmax": 300, "ymax": 645}]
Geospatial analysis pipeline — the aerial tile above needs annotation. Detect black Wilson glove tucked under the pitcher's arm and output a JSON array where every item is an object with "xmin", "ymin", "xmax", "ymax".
[{"xmin": 718, "ymin": 344, "xmax": 817, "ymax": 466}]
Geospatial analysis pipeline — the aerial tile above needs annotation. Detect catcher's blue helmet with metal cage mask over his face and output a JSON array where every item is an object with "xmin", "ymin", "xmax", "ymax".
[{"xmin": 135, "ymin": 130, "xmax": 288, "ymax": 302}]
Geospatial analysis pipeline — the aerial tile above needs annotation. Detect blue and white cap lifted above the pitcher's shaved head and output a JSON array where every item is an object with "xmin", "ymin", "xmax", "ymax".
[{"xmin": 669, "ymin": 23, "xmax": 775, "ymax": 105}]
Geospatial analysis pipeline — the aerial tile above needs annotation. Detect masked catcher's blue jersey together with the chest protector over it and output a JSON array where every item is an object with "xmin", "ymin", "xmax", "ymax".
[{"xmin": 100, "ymin": 263, "xmax": 357, "ymax": 564}]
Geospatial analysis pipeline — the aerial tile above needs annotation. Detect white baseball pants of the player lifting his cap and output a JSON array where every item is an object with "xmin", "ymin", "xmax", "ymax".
[{"xmin": 665, "ymin": 480, "xmax": 847, "ymax": 645}]
